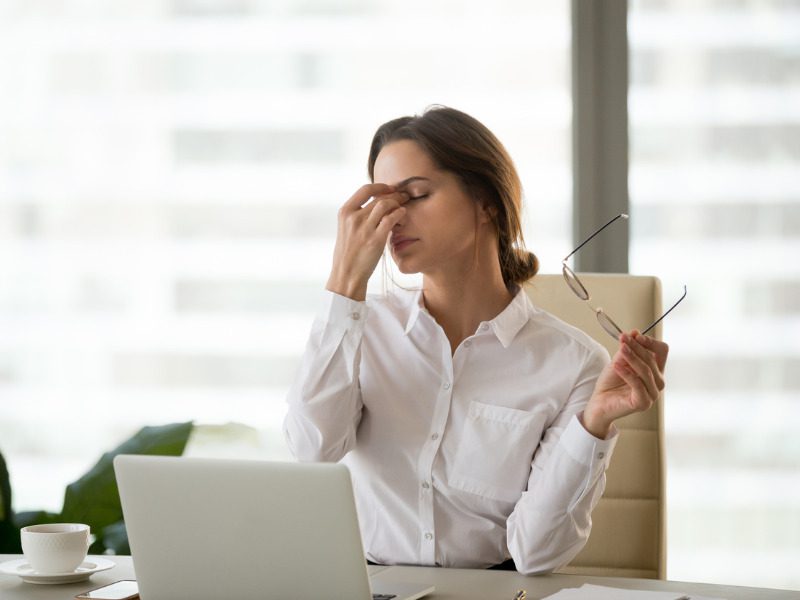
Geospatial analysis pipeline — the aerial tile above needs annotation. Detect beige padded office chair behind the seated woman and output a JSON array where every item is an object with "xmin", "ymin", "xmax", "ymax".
[{"xmin": 526, "ymin": 273, "xmax": 666, "ymax": 579}]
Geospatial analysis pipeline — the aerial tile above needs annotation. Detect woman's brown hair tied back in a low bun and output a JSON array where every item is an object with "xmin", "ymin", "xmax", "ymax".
[{"xmin": 367, "ymin": 106, "xmax": 539, "ymax": 289}]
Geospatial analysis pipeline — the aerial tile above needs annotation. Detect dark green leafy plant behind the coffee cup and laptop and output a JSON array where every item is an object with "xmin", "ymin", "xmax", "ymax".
[{"xmin": 0, "ymin": 421, "xmax": 193, "ymax": 554}]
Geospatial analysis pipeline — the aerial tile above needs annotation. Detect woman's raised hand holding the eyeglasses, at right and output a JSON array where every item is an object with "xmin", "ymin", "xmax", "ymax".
[{"xmin": 583, "ymin": 330, "xmax": 669, "ymax": 439}]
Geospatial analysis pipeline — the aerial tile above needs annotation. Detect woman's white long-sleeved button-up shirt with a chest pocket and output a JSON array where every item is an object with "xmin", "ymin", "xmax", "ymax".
[{"xmin": 284, "ymin": 291, "xmax": 617, "ymax": 573}]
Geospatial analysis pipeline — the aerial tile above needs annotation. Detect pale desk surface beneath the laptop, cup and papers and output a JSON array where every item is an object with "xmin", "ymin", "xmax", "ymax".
[{"xmin": 0, "ymin": 555, "xmax": 800, "ymax": 600}]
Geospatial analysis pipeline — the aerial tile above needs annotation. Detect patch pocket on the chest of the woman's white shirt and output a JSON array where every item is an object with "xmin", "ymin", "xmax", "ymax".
[{"xmin": 449, "ymin": 401, "xmax": 547, "ymax": 502}]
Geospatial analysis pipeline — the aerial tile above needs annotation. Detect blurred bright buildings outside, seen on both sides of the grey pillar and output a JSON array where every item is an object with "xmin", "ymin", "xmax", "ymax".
[{"xmin": 0, "ymin": 0, "xmax": 800, "ymax": 589}]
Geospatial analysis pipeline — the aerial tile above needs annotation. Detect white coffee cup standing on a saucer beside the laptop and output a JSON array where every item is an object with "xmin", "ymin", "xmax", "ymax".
[{"xmin": 20, "ymin": 523, "xmax": 89, "ymax": 575}]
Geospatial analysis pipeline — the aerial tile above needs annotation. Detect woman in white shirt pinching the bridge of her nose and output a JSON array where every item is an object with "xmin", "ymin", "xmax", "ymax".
[{"xmin": 284, "ymin": 107, "xmax": 667, "ymax": 574}]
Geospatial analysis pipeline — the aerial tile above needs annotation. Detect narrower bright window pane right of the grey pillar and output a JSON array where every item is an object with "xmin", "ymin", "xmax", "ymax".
[{"xmin": 629, "ymin": 0, "xmax": 800, "ymax": 589}]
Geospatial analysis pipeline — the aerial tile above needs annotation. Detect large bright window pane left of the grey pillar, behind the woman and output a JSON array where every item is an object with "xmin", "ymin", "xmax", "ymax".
[{"xmin": 0, "ymin": 0, "xmax": 571, "ymax": 511}]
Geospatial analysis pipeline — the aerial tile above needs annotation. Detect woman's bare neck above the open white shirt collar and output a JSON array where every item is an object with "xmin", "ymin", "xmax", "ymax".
[{"xmin": 423, "ymin": 256, "xmax": 513, "ymax": 352}]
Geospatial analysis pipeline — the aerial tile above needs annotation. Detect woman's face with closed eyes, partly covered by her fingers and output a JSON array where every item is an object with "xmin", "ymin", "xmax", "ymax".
[{"xmin": 373, "ymin": 140, "xmax": 487, "ymax": 275}]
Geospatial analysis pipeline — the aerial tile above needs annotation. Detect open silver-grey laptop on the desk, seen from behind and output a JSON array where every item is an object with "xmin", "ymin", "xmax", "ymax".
[{"xmin": 114, "ymin": 455, "xmax": 434, "ymax": 600}]
